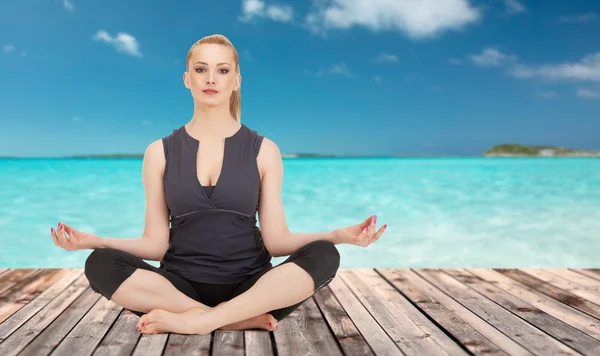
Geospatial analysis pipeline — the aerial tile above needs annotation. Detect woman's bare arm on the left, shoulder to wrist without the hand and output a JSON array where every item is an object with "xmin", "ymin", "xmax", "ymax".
[{"xmin": 98, "ymin": 140, "xmax": 169, "ymax": 261}]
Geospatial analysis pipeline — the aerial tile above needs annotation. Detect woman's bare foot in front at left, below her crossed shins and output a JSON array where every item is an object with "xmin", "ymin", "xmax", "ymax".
[{"xmin": 136, "ymin": 308, "xmax": 206, "ymax": 334}]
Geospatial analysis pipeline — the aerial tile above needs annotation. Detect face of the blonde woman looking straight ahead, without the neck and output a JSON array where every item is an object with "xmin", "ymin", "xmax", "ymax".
[{"xmin": 183, "ymin": 44, "xmax": 241, "ymax": 106}]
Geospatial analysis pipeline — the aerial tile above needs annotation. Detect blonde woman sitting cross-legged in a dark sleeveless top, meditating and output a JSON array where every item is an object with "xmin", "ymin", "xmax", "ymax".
[{"xmin": 51, "ymin": 35, "xmax": 386, "ymax": 334}]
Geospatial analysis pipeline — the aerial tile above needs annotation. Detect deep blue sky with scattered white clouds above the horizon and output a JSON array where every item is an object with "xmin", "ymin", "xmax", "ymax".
[{"xmin": 0, "ymin": 0, "xmax": 600, "ymax": 157}]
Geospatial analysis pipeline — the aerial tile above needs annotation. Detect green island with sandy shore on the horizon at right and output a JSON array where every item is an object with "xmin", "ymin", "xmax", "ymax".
[{"xmin": 484, "ymin": 144, "xmax": 600, "ymax": 157}]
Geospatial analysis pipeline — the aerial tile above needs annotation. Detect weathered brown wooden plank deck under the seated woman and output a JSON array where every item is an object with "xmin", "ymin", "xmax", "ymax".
[{"xmin": 0, "ymin": 269, "xmax": 600, "ymax": 356}]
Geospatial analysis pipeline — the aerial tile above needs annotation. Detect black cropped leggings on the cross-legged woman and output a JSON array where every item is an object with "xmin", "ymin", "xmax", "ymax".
[{"xmin": 85, "ymin": 240, "xmax": 340, "ymax": 321}]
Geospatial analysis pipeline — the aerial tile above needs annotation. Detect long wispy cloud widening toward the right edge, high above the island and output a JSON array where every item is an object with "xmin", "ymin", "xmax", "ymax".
[{"xmin": 509, "ymin": 52, "xmax": 600, "ymax": 81}]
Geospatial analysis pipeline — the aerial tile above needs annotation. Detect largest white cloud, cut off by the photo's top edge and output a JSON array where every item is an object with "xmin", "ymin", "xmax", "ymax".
[{"xmin": 305, "ymin": 0, "xmax": 481, "ymax": 39}]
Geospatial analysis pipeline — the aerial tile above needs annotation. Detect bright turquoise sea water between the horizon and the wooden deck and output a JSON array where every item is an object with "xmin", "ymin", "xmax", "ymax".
[{"xmin": 0, "ymin": 158, "xmax": 600, "ymax": 268}]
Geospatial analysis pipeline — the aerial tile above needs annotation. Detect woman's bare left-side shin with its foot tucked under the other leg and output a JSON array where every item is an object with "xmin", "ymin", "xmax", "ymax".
[{"xmin": 111, "ymin": 269, "xmax": 276, "ymax": 330}]
